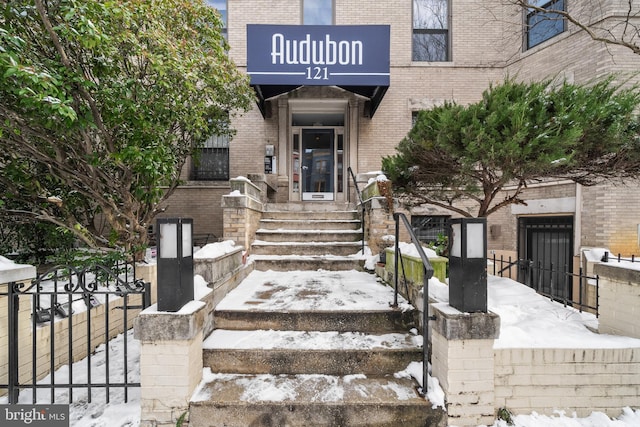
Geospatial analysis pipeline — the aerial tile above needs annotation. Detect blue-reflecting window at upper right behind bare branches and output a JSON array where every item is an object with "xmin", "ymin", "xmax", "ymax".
[{"xmin": 525, "ymin": 0, "xmax": 565, "ymax": 49}]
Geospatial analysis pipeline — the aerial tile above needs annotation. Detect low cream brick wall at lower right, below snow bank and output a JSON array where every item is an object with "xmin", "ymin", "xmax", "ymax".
[{"xmin": 495, "ymin": 348, "xmax": 640, "ymax": 417}]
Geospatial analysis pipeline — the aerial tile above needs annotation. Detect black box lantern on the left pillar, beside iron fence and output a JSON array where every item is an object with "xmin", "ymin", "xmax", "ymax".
[{"xmin": 157, "ymin": 218, "xmax": 193, "ymax": 311}]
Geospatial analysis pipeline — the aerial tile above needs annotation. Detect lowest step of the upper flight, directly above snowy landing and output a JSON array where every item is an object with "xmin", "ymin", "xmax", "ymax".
[{"xmin": 251, "ymin": 255, "xmax": 364, "ymax": 272}]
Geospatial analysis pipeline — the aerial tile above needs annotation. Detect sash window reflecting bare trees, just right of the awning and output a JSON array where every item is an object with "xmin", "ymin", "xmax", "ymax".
[{"xmin": 413, "ymin": 0, "xmax": 449, "ymax": 62}]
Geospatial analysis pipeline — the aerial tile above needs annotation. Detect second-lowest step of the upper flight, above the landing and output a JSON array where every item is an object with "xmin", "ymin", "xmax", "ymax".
[{"xmin": 251, "ymin": 240, "xmax": 362, "ymax": 256}]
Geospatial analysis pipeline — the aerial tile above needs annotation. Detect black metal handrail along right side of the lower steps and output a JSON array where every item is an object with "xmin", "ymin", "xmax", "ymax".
[{"xmin": 393, "ymin": 212, "xmax": 433, "ymax": 396}]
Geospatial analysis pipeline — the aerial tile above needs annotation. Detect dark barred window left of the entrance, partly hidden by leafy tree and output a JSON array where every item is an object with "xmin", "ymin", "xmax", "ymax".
[{"xmin": 192, "ymin": 135, "xmax": 229, "ymax": 181}]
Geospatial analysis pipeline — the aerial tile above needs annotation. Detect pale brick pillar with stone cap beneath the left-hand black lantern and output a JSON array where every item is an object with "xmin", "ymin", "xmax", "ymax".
[{"xmin": 134, "ymin": 301, "xmax": 205, "ymax": 427}]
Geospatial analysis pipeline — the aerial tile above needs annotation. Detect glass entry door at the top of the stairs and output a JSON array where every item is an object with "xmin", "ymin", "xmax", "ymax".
[{"xmin": 300, "ymin": 128, "xmax": 336, "ymax": 200}]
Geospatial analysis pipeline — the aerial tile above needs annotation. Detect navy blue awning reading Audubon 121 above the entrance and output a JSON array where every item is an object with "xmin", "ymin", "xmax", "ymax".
[{"xmin": 247, "ymin": 24, "xmax": 390, "ymax": 117}]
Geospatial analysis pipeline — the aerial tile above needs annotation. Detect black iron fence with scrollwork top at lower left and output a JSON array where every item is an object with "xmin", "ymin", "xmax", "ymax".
[{"xmin": 0, "ymin": 263, "xmax": 151, "ymax": 404}]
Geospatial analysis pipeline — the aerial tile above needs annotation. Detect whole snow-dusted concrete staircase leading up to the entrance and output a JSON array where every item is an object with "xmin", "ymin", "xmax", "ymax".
[{"xmin": 189, "ymin": 209, "xmax": 446, "ymax": 427}]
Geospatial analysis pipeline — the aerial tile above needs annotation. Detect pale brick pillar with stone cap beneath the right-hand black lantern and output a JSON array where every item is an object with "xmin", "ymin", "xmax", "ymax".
[{"xmin": 431, "ymin": 304, "xmax": 500, "ymax": 427}]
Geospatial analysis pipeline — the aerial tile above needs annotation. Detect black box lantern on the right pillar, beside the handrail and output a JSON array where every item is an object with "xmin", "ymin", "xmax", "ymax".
[{"xmin": 449, "ymin": 218, "xmax": 487, "ymax": 313}]
